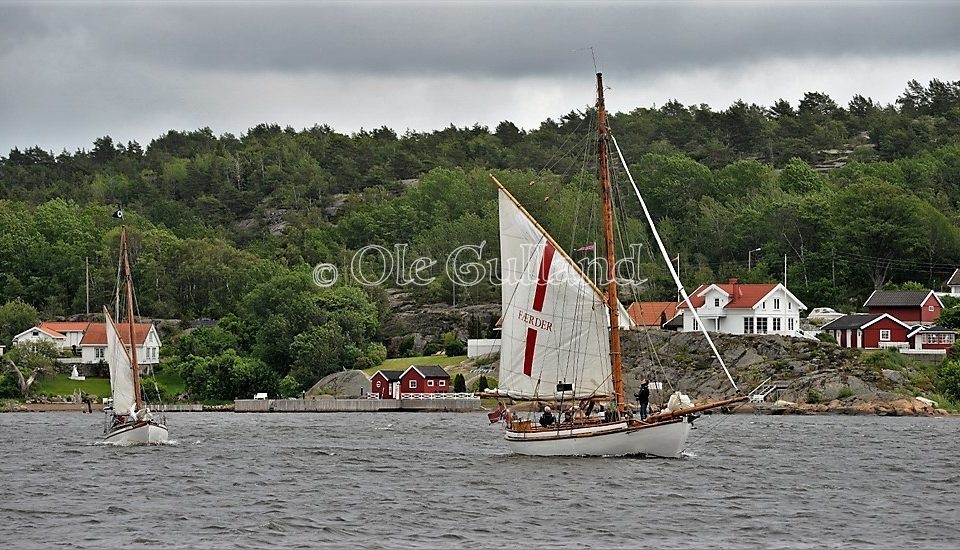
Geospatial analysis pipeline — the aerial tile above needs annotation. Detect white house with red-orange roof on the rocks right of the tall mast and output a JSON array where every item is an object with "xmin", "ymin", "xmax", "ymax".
[{"xmin": 677, "ymin": 279, "xmax": 807, "ymax": 336}]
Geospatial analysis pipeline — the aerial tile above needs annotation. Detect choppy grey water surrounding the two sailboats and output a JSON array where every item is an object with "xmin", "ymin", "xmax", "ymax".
[{"xmin": 0, "ymin": 413, "xmax": 960, "ymax": 549}]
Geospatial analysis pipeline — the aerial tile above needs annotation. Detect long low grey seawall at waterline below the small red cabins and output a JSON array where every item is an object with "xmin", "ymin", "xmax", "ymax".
[{"xmin": 233, "ymin": 398, "xmax": 483, "ymax": 413}]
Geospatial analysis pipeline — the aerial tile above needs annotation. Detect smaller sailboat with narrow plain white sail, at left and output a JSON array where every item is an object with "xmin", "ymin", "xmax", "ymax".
[{"xmin": 103, "ymin": 226, "xmax": 169, "ymax": 445}]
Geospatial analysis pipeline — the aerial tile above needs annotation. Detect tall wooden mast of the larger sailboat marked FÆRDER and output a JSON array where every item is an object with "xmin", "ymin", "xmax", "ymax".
[{"xmin": 597, "ymin": 73, "xmax": 626, "ymax": 413}]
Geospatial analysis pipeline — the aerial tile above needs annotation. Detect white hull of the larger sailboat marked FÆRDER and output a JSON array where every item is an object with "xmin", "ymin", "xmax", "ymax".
[{"xmin": 504, "ymin": 419, "xmax": 690, "ymax": 458}]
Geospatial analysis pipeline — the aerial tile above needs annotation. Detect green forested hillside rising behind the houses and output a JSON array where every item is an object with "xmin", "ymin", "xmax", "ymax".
[{"xmin": 0, "ymin": 80, "xmax": 960, "ymax": 394}]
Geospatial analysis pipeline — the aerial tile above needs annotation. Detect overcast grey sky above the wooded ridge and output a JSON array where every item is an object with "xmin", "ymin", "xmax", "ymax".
[{"xmin": 0, "ymin": 0, "xmax": 960, "ymax": 156}]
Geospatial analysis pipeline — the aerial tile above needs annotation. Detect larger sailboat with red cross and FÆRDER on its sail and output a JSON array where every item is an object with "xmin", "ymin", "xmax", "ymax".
[{"xmin": 491, "ymin": 73, "xmax": 747, "ymax": 458}]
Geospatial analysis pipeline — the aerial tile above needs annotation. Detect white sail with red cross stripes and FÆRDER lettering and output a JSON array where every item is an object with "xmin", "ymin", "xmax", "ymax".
[{"xmin": 498, "ymin": 188, "xmax": 629, "ymax": 399}]
